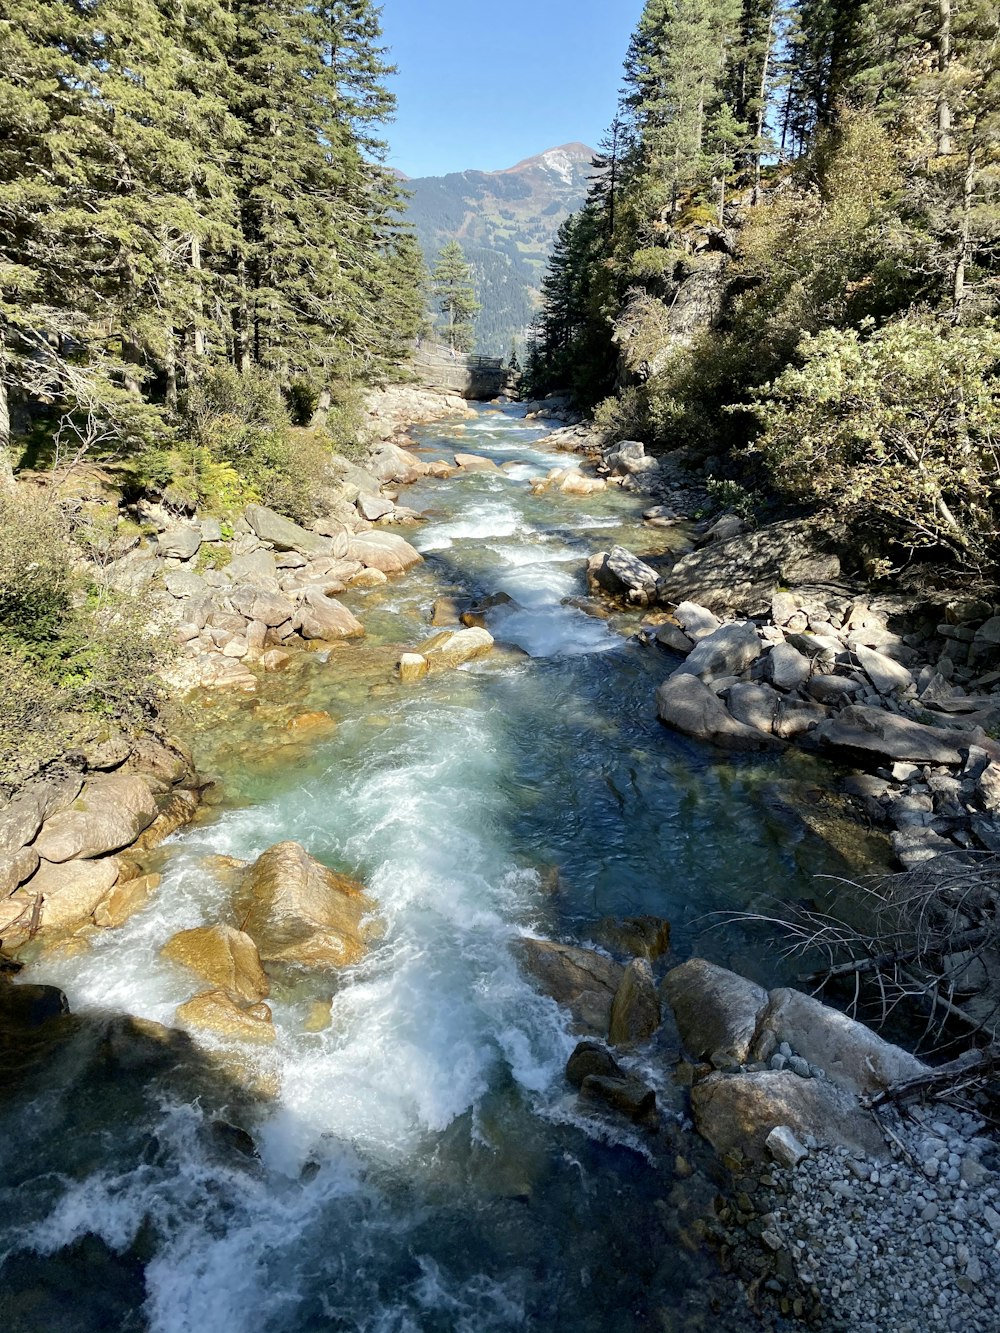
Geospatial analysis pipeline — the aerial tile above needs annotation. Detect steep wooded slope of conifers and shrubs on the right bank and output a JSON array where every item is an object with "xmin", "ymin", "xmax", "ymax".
[{"xmin": 532, "ymin": 0, "xmax": 1000, "ymax": 568}]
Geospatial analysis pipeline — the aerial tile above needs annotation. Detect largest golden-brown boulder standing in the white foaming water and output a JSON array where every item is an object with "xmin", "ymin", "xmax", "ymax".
[{"xmin": 235, "ymin": 842, "xmax": 379, "ymax": 968}]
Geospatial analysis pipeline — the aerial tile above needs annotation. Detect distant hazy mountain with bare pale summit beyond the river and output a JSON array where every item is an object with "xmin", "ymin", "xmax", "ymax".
[{"xmin": 405, "ymin": 144, "xmax": 593, "ymax": 356}]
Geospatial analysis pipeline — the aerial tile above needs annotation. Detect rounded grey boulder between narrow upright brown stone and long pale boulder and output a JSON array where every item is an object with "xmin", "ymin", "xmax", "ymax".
[{"xmin": 663, "ymin": 958, "xmax": 768, "ymax": 1069}]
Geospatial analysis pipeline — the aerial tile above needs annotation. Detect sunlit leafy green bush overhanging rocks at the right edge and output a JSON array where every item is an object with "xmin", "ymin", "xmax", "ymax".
[{"xmin": 753, "ymin": 319, "xmax": 1000, "ymax": 564}]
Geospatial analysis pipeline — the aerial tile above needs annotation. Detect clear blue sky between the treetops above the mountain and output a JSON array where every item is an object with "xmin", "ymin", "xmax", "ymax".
[{"xmin": 383, "ymin": 0, "xmax": 643, "ymax": 176}]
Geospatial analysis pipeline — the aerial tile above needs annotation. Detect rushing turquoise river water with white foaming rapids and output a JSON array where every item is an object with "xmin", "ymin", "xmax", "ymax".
[{"xmin": 0, "ymin": 409, "xmax": 890, "ymax": 1333}]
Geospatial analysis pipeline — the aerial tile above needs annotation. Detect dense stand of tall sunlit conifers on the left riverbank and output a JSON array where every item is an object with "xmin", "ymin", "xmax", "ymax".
[{"xmin": 0, "ymin": 0, "xmax": 423, "ymax": 479}]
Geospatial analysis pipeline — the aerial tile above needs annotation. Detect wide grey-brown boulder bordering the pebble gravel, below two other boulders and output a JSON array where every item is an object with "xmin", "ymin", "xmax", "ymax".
[{"xmin": 691, "ymin": 1069, "xmax": 888, "ymax": 1164}]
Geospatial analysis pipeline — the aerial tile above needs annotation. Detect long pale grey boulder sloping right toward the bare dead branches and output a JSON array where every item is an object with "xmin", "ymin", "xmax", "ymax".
[{"xmin": 753, "ymin": 989, "xmax": 927, "ymax": 1096}]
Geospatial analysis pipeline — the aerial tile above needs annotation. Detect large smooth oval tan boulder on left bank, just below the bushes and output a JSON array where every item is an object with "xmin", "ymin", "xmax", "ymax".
[{"xmin": 33, "ymin": 773, "xmax": 159, "ymax": 862}]
